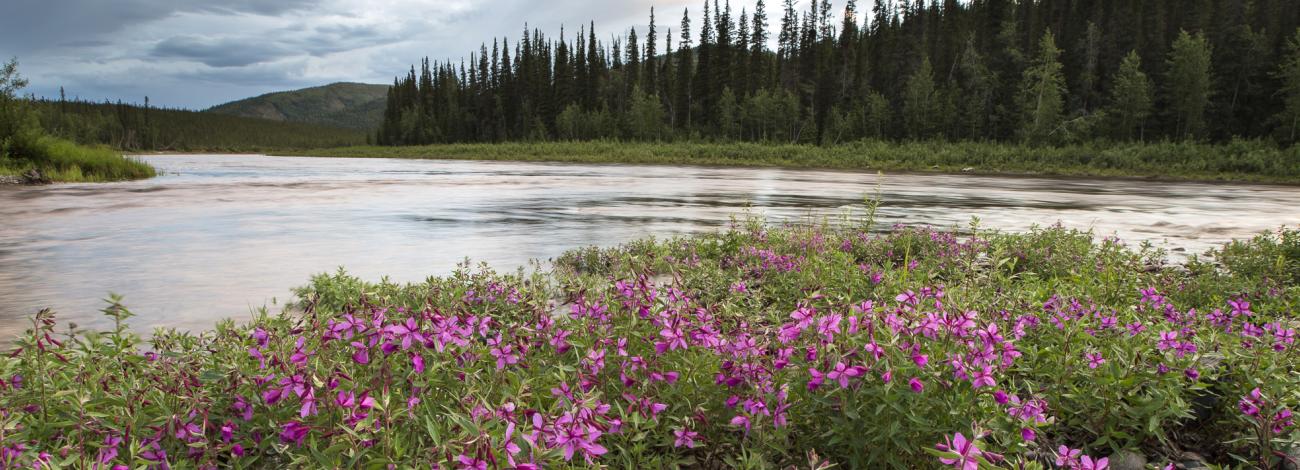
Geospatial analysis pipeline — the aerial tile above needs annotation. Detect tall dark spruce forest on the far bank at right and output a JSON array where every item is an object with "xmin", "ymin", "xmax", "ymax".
[{"xmin": 376, "ymin": 0, "xmax": 1300, "ymax": 144}]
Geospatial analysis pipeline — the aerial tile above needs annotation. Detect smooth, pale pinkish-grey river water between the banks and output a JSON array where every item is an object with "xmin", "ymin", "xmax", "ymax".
[{"xmin": 0, "ymin": 156, "xmax": 1300, "ymax": 338}]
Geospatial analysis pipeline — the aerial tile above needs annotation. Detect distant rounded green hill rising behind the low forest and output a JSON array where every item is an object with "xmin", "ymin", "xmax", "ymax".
[{"xmin": 205, "ymin": 83, "xmax": 389, "ymax": 131}]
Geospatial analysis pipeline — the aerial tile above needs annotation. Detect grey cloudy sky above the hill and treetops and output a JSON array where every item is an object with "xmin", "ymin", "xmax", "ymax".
[{"xmin": 0, "ymin": 0, "xmax": 800, "ymax": 109}]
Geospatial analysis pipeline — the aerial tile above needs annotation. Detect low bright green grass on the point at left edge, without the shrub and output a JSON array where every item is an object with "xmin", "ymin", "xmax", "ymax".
[{"xmin": 0, "ymin": 136, "xmax": 157, "ymax": 183}]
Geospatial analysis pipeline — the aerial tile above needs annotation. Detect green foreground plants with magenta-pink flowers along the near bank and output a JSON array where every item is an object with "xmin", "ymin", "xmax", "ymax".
[{"xmin": 0, "ymin": 218, "xmax": 1300, "ymax": 469}]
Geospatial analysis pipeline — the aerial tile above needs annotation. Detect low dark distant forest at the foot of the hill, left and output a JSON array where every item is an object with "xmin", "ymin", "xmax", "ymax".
[{"xmin": 29, "ymin": 97, "xmax": 367, "ymax": 151}]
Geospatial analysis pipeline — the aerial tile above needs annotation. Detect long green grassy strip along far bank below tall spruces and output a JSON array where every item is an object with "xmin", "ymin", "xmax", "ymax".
[{"xmin": 282, "ymin": 140, "xmax": 1300, "ymax": 184}]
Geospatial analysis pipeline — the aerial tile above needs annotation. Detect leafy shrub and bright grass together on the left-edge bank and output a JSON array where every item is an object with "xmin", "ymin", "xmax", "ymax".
[{"xmin": 0, "ymin": 60, "xmax": 155, "ymax": 183}]
